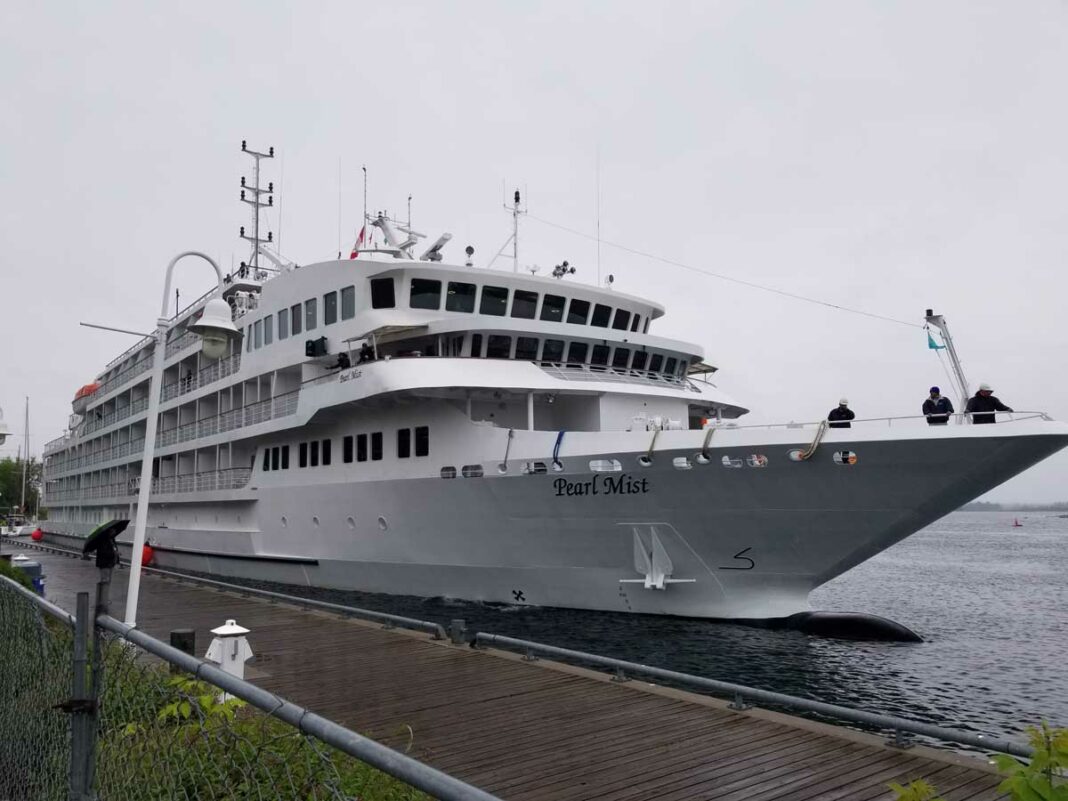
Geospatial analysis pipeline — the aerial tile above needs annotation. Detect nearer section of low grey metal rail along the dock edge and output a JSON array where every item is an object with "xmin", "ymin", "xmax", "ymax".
[{"xmin": 473, "ymin": 631, "xmax": 1034, "ymax": 757}]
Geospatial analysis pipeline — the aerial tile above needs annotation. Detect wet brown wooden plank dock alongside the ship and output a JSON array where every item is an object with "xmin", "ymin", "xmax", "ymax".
[{"xmin": 25, "ymin": 541, "xmax": 1006, "ymax": 801}]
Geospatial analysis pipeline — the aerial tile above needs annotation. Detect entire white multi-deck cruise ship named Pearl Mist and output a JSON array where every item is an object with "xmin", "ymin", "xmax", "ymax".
[{"xmin": 42, "ymin": 149, "xmax": 1068, "ymax": 619}]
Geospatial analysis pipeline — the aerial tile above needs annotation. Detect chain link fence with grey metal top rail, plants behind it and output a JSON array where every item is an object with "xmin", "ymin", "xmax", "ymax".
[{"xmin": 0, "ymin": 578, "xmax": 493, "ymax": 801}]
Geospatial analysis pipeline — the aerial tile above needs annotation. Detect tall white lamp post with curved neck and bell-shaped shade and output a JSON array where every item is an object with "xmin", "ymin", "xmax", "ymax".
[{"xmin": 126, "ymin": 250, "xmax": 237, "ymax": 626}]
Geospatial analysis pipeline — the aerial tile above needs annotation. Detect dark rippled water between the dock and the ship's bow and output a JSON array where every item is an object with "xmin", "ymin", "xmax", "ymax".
[{"xmin": 229, "ymin": 513, "xmax": 1068, "ymax": 747}]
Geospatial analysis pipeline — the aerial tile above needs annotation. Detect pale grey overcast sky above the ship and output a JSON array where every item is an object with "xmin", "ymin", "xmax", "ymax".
[{"xmin": 0, "ymin": 0, "xmax": 1068, "ymax": 501}]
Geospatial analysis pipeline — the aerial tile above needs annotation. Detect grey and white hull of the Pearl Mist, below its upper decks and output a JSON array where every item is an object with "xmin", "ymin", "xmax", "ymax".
[{"xmin": 43, "ymin": 420, "xmax": 1068, "ymax": 619}]
